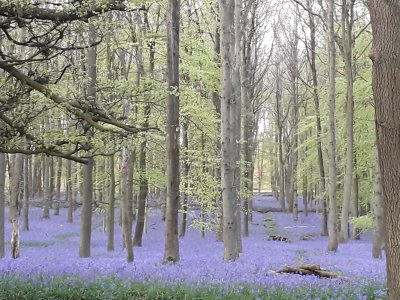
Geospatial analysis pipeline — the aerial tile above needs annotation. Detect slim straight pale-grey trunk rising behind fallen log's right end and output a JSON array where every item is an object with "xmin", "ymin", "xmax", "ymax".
[{"xmin": 328, "ymin": 0, "xmax": 338, "ymax": 251}]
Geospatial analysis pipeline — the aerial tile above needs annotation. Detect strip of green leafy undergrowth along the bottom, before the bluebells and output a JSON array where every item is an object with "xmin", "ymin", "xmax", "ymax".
[{"xmin": 0, "ymin": 276, "xmax": 386, "ymax": 300}]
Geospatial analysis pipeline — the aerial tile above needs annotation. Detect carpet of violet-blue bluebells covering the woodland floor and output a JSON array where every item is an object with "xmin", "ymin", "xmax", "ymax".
[{"xmin": 0, "ymin": 196, "xmax": 386, "ymax": 293}]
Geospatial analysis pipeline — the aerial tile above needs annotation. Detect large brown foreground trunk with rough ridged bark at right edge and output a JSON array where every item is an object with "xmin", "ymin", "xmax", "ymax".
[{"xmin": 368, "ymin": 0, "xmax": 400, "ymax": 300}]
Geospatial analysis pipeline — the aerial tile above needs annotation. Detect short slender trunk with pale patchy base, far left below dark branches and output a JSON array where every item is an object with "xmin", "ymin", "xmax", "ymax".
[{"xmin": 10, "ymin": 153, "xmax": 24, "ymax": 259}]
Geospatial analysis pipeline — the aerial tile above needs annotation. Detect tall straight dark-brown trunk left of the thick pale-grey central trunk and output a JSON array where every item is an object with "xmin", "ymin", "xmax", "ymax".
[{"xmin": 164, "ymin": 0, "xmax": 180, "ymax": 263}]
